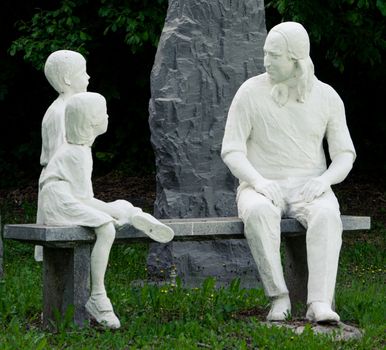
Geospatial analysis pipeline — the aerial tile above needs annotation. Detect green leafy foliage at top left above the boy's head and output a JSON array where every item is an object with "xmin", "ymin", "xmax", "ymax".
[{"xmin": 9, "ymin": 0, "xmax": 167, "ymax": 69}]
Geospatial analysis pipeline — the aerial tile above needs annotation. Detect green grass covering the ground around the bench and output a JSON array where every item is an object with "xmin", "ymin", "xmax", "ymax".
[{"xmin": 0, "ymin": 201, "xmax": 386, "ymax": 350}]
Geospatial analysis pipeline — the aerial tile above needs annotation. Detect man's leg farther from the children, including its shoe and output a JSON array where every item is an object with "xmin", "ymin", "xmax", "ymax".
[{"xmin": 292, "ymin": 190, "xmax": 342, "ymax": 322}]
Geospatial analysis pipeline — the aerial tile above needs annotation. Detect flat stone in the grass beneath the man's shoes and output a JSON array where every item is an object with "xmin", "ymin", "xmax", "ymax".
[{"xmin": 263, "ymin": 321, "xmax": 363, "ymax": 341}]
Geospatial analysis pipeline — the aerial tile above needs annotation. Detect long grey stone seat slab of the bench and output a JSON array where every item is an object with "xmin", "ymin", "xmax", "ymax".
[{"xmin": 4, "ymin": 215, "xmax": 371, "ymax": 242}]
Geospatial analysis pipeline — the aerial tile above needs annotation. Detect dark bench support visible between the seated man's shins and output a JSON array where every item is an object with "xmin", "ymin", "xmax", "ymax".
[{"xmin": 283, "ymin": 234, "xmax": 308, "ymax": 313}]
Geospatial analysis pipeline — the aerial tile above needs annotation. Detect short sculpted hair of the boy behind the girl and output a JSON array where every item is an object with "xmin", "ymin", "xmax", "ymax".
[{"xmin": 44, "ymin": 50, "xmax": 86, "ymax": 93}]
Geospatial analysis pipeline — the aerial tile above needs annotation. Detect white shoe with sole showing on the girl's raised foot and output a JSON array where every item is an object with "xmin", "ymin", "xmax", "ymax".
[{"xmin": 131, "ymin": 212, "xmax": 174, "ymax": 243}]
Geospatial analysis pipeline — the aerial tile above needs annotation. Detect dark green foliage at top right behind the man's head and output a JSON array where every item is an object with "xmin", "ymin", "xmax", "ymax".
[{"xmin": 266, "ymin": 0, "xmax": 386, "ymax": 72}]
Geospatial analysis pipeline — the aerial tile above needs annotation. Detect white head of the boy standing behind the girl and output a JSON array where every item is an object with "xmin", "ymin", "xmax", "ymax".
[{"xmin": 44, "ymin": 50, "xmax": 90, "ymax": 94}]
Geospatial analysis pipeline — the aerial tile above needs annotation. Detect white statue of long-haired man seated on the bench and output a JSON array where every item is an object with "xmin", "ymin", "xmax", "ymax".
[{"xmin": 221, "ymin": 22, "xmax": 356, "ymax": 322}]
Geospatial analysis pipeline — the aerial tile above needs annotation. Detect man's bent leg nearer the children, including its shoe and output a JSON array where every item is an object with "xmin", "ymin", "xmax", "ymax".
[{"xmin": 237, "ymin": 187, "xmax": 291, "ymax": 321}]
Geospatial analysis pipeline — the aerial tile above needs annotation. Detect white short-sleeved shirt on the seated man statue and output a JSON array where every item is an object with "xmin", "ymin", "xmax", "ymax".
[{"xmin": 221, "ymin": 74, "xmax": 356, "ymax": 183}]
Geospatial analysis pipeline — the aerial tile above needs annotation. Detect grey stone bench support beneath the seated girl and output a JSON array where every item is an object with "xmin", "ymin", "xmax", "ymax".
[{"xmin": 43, "ymin": 244, "xmax": 91, "ymax": 328}]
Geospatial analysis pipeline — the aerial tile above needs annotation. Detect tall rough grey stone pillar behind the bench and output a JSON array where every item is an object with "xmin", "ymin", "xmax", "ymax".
[{"xmin": 148, "ymin": 0, "xmax": 266, "ymax": 286}]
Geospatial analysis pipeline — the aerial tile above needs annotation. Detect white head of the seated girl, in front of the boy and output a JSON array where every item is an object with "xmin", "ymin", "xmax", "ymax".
[{"xmin": 65, "ymin": 92, "xmax": 108, "ymax": 146}]
